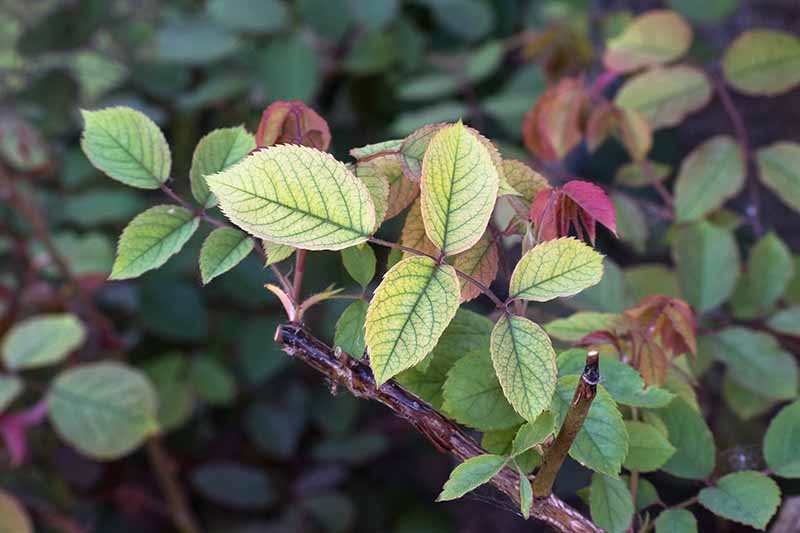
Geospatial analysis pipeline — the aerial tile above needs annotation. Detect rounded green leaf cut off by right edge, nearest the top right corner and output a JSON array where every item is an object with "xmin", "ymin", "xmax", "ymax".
[{"xmin": 722, "ymin": 29, "xmax": 800, "ymax": 96}]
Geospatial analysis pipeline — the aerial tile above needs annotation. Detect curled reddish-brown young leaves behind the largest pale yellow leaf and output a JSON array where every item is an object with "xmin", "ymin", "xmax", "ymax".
[{"xmin": 256, "ymin": 100, "xmax": 331, "ymax": 151}]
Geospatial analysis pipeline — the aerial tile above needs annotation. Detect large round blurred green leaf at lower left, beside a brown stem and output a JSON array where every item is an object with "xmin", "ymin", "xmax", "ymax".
[{"xmin": 47, "ymin": 362, "xmax": 158, "ymax": 460}]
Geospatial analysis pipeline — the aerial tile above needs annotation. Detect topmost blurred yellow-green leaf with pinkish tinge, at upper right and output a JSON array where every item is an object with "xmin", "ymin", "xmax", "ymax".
[{"xmin": 603, "ymin": 10, "xmax": 692, "ymax": 72}]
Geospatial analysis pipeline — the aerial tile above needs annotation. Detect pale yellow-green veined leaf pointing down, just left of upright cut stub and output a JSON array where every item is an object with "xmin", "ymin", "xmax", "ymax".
[{"xmin": 491, "ymin": 315, "xmax": 558, "ymax": 422}]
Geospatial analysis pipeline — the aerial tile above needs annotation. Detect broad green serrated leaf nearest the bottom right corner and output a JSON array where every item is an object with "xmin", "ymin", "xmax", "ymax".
[{"xmin": 698, "ymin": 471, "xmax": 781, "ymax": 529}]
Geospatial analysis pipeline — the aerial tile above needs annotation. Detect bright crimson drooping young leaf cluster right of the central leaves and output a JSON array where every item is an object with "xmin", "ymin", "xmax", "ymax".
[{"xmin": 530, "ymin": 180, "xmax": 617, "ymax": 244}]
